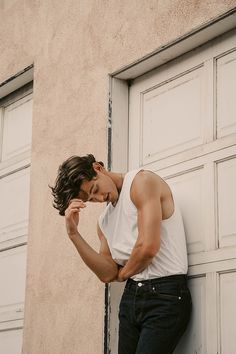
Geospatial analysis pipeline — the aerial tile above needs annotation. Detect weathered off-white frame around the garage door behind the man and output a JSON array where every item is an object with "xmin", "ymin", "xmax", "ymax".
[{"xmin": 104, "ymin": 7, "xmax": 236, "ymax": 354}]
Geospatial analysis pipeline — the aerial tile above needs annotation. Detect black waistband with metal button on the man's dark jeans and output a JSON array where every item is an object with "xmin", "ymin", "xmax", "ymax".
[{"xmin": 125, "ymin": 274, "xmax": 188, "ymax": 288}]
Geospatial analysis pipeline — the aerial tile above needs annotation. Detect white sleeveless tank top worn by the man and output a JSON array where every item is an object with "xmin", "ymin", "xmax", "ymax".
[{"xmin": 99, "ymin": 168, "xmax": 188, "ymax": 280}]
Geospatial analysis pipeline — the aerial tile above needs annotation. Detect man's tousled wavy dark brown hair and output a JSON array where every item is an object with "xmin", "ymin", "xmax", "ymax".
[{"xmin": 49, "ymin": 154, "xmax": 104, "ymax": 215}]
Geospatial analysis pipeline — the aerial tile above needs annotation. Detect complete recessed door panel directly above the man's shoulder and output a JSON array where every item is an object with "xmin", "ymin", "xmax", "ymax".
[{"xmin": 140, "ymin": 67, "xmax": 204, "ymax": 164}]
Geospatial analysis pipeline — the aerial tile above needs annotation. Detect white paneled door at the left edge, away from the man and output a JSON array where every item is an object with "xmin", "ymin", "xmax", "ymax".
[{"xmin": 0, "ymin": 90, "xmax": 32, "ymax": 354}]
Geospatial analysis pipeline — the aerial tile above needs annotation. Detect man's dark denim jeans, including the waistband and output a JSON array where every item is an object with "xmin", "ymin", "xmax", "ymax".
[{"xmin": 118, "ymin": 275, "xmax": 192, "ymax": 354}]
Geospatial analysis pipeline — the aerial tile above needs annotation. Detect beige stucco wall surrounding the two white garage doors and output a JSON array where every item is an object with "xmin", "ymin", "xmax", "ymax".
[{"xmin": 0, "ymin": 0, "xmax": 236, "ymax": 354}]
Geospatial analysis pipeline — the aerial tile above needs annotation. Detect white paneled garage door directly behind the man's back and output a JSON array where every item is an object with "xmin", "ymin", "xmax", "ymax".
[{"xmin": 129, "ymin": 31, "xmax": 236, "ymax": 354}]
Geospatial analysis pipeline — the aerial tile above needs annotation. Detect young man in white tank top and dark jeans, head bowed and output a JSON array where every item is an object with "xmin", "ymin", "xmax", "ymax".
[{"xmin": 52, "ymin": 154, "xmax": 192, "ymax": 354}]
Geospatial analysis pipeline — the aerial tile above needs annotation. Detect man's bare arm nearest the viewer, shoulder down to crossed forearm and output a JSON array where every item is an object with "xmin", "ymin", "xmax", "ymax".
[{"xmin": 118, "ymin": 171, "xmax": 162, "ymax": 281}]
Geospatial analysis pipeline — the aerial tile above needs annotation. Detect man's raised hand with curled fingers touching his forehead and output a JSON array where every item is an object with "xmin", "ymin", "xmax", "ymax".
[{"xmin": 65, "ymin": 199, "xmax": 86, "ymax": 239}]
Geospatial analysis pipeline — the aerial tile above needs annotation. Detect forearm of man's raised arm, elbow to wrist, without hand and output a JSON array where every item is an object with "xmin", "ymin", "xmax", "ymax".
[{"xmin": 70, "ymin": 232, "xmax": 118, "ymax": 283}]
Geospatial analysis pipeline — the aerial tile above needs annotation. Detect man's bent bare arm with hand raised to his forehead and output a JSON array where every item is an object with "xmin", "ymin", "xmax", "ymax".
[{"xmin": 65, "ymin": 199, "xmax": 118, "ymax": 283}]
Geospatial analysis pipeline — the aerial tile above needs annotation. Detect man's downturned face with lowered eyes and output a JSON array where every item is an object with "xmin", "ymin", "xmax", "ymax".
[{"xmin": 78, "ymin": 171, "xmax": 118, "ymax": 204}]
